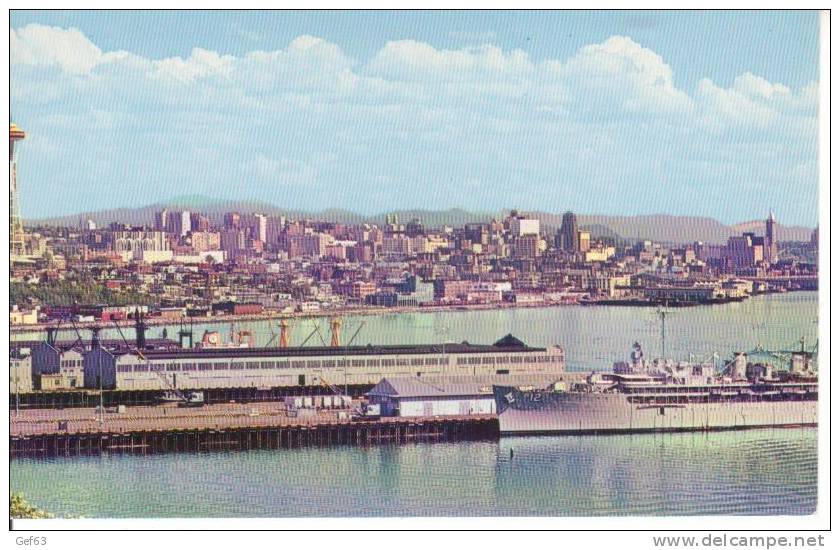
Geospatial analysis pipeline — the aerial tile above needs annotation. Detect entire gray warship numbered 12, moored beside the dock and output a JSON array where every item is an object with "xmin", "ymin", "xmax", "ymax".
[{"xmin": 493, "ymin": 342, "xmax": 818, "ymax": 435}]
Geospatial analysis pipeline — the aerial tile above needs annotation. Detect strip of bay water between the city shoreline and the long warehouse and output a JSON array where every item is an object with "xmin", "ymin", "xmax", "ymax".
[{"xmin": 13, "ymin": 292, "xmax": 817, "ymax": 370}]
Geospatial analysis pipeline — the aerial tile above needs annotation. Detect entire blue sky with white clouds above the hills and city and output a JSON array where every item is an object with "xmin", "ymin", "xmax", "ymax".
[{"xmin": 10, "ymin": 10, "xmax": 819, "ymax": 227}]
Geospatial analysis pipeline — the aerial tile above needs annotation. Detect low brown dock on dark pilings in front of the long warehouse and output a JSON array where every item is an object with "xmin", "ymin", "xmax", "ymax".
[{"xmin": 9, "ymin": 403, "xmax": 499, "ymax": 459}]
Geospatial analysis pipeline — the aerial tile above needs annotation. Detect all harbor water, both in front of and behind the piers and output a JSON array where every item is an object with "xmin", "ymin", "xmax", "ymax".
[{"xmin": 11, "ymin": 292, "xmax": 817, "ymax": 517}]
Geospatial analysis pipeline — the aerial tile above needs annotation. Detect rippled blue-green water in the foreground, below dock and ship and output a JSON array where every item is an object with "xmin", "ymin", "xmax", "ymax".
[{"xmin": 11, "ymin": 429, "xmax": 817, "ymax": 518}]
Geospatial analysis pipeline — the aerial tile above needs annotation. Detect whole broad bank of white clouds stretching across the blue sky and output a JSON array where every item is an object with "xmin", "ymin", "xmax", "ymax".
[{"xmin": 11, "ymin": 25, "xmax": 818, "ymax": 224}]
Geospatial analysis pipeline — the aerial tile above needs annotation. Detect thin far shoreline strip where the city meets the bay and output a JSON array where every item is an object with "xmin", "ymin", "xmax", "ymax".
[{"xmin": 9, "ymin": 290, "xmax": 818, "ymax": 335}]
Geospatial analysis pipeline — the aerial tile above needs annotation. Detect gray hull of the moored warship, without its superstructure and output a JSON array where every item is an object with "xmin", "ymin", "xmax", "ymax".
[{"xmin": 493, "ymin": 386, "xmax": 817, "ymax": 435}]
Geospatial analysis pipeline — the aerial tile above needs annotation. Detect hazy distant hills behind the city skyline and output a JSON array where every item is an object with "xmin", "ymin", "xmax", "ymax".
[{"xmin": 26, "ymin": 195, "xmax": 811, "ymax": 244}]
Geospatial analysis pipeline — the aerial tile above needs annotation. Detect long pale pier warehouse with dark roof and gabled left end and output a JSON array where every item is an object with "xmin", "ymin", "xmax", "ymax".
[{"xmin": 9, "ymin": 320, "xmax": 565, "ymax": 408}]
